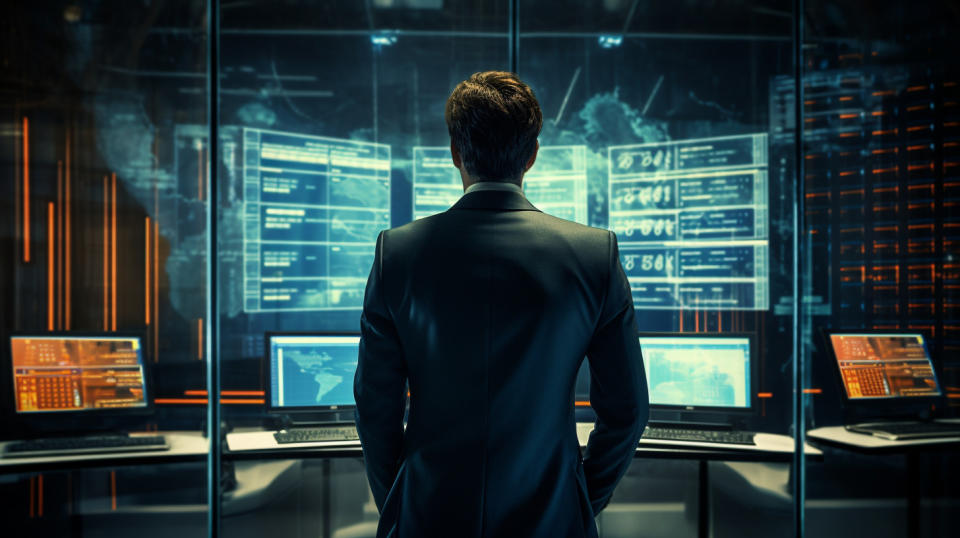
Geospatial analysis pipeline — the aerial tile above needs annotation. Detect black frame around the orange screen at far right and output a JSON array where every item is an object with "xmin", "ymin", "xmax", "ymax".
[{"xmin": 820, "ymin": 328, "xmax": 946, "ymax": 408}]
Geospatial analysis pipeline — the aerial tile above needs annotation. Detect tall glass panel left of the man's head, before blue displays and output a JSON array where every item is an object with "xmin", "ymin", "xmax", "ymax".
[{"xmin": 217, "ymin": 0, "xmax": 509, "ymax": 536}]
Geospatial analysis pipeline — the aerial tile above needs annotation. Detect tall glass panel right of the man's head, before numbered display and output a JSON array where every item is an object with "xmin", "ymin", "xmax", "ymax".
[{"xmin": 518, "ymin": 0, "xmax": 795, "ymax": 536}]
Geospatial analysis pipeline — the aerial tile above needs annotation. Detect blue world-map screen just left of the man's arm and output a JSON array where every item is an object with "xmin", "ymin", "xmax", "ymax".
[{"xmin": 267, "ymin": 334, "xmax": 360, "ymax": 409}]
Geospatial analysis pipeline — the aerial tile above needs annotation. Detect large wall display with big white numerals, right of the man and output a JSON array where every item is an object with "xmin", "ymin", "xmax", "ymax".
[{"xmin": 608, "ymin": 134, "xmax": 770, "ymax": 310}]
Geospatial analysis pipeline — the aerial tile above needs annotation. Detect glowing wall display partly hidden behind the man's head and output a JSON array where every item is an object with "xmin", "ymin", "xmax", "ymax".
[{"xmin": 413, "ymin": 142, "xmax": 587, "ymax": 224}]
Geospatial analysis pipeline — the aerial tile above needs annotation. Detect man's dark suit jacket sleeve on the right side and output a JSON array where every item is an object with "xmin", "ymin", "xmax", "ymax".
[{"xmin": 583, "ymin": 232, "xmax": 649, "ymax": 514}]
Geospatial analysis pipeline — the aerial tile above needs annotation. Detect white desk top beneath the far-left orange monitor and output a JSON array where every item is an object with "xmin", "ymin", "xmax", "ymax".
[{"xmin": 0, "ymin": 432, "xmax": 210, "ymax": 474}]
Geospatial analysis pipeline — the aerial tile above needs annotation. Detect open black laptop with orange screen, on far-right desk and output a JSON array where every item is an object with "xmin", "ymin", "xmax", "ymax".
[{"xmin": 824, "ymin": 330, "xmax": 960, "ymax": 440}]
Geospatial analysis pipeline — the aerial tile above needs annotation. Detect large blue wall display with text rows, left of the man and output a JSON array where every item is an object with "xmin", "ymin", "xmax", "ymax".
[{"xmin": 243, "ymin": 129, "xmax": 390, "ymax": 312}]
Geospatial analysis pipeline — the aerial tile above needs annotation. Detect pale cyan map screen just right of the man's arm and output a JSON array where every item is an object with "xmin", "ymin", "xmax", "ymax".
[{"xmin": 640, "ymin": 335, "xmax": 750, "ymax": 409}]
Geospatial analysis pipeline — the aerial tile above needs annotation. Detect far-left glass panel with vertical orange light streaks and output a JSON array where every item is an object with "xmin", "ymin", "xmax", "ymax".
[{"xmin": 0, "ymin": 1, "xmax": 208, "ymax": 536}]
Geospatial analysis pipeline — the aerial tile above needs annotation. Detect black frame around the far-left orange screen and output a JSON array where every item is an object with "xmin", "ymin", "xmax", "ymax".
[{"xmin": 0, "ymin": 330, "xmax": 156, "ymax": 433}]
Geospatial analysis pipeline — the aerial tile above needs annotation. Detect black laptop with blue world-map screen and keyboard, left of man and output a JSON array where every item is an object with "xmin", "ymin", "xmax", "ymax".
[{"xmin": 227, "ymin": 332, "xmax": 360, "ymax": 450}]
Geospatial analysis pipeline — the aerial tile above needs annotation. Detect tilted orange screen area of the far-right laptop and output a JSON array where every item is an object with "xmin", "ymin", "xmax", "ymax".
[{"xmin": 830, "ymin": 332, "xmax": 941, "ymax": 400}]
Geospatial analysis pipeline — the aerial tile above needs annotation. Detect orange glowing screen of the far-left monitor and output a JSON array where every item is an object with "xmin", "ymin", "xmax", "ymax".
[{"xmin": 10, "ymin": 336, "xmax": 148, "ymax": 413}]
